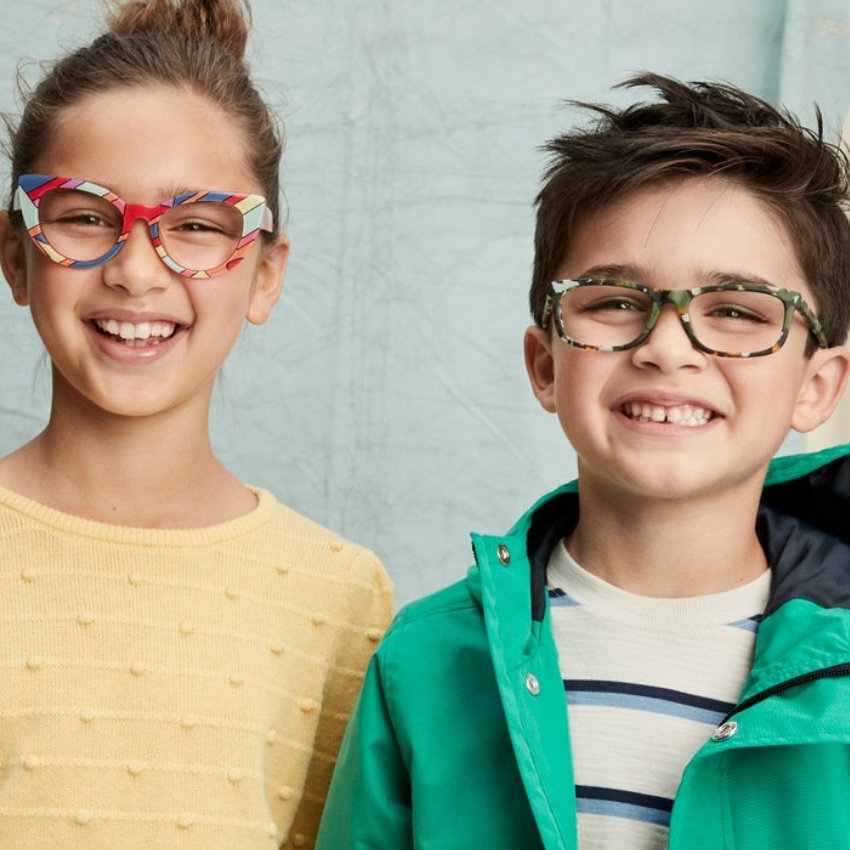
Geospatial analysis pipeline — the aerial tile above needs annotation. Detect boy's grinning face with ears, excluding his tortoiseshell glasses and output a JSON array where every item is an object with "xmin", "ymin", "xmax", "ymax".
[{"xmin": 525, "ymin": 172, "xmax": 848, "ymax": 501}]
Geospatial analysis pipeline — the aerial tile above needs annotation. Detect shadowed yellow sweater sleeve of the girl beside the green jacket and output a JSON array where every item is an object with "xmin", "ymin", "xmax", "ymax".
[{"xmin": 282, "ymin": 549, "xmax": 393, "ymax": 848}]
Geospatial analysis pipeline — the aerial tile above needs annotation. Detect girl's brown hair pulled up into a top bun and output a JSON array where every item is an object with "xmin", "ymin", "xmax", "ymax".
[{"xmin": 7, "ymin": 0, "xmax": 283, "ymax": 235}]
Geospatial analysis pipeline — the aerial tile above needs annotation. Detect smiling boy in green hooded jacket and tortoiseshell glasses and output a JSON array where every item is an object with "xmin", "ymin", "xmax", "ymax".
[{"xmin": 318, "ymin": 75, "xmax": 850, "ymax": 850}]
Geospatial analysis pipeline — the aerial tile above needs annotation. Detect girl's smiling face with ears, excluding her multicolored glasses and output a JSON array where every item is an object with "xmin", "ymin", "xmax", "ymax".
[{"xmin": 0, "ymin": 85, "xmax": 288, "ymax": 417}]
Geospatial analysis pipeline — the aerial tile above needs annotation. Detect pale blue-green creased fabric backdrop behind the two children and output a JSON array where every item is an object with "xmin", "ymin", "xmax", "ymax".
[{"xmin": 0, "ymin": 0, "xmax": 850, "ymax": 602}]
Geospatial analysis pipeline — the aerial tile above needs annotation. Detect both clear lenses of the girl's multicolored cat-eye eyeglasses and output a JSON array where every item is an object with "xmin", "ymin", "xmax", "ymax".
[{"xmin": 38, "ymin": 189, "xmax": 242, "ymax": 270}]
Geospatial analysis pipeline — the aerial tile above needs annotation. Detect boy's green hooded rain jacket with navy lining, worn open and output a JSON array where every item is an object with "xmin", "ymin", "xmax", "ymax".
[{"xmin": 317, "ymin": 445, "xmax": 850, "ymax": 850}]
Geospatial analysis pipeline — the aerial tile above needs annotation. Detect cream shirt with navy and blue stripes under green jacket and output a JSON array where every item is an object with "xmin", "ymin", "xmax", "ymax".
[{"xmin": 548, "ymin": 545, "xmax": 770, "ymax": 850}]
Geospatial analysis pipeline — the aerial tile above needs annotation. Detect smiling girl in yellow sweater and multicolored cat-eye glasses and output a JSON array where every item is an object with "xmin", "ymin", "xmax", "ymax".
[{"xmin": 0, "ymin": 0, "xmax": 391, "ymax": 850}]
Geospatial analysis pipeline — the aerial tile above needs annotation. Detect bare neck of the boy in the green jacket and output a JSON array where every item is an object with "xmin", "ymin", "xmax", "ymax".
[{"xmin": 567, "ymin": 488, "xmax": 769, "ymax": 598}]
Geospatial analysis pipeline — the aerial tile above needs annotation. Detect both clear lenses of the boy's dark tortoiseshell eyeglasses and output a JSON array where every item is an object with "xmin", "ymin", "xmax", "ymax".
[{"xmin": 560, "ymin": 285, "xmax": 786, "ymax": 354}]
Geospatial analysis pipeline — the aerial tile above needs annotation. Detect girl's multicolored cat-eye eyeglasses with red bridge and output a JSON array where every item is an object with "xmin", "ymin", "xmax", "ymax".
[{"xmin": 14, "ymin": 174, "xmax": 273, "ymax": 279}]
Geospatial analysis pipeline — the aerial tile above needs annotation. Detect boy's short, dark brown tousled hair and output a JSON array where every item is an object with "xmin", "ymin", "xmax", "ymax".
[{"xmin": 530, "ymin": 74, "xmax": 850, "ymax": 345}]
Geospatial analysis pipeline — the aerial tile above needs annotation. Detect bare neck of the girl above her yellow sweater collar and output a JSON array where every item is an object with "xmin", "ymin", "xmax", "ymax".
[{"xmin": 0, "ymin": 396, "xmax": 256, "ymax": 528}]
